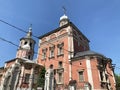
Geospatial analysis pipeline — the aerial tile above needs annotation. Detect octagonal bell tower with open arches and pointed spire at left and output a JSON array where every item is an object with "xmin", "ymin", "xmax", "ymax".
[{"xmin": 16, "ymin": 26, "xmax": 35, "ymax": 60}]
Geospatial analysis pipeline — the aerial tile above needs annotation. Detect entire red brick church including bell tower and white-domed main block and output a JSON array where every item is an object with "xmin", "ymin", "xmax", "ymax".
[{"xmin": 0, "ymin": 15, "xmax": 116, "ymax": 90}]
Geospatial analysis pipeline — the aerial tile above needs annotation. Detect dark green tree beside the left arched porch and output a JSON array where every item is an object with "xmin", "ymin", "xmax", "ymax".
[{"xmin": 37, "ymin": 67, "xmax": 46, "ymax": 88}]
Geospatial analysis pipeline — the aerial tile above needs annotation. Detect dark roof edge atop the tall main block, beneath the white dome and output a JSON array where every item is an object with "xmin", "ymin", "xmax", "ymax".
[{"xmin": 39, "ymin": 22, "xmax": 89, "ymax": 42}]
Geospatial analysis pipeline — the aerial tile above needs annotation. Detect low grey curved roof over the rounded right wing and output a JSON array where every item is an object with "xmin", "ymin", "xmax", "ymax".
[{"xmin": 73, "ymin": 50, "xmax": 105, "ymax": 58}]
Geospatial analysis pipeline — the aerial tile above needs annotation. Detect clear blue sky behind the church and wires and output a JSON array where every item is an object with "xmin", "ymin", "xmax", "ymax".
[{"xmin": 0, "ymin": 0, "xmax": 120, "ymax": 73}]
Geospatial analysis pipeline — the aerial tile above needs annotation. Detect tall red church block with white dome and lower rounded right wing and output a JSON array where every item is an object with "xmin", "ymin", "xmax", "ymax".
[{"xmin": 38, "ymin": 15, "xmax": 115, "ymax": 90}]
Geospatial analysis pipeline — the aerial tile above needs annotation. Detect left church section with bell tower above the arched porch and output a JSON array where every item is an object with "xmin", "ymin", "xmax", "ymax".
[{"xmin": 0, "ymin": 28, "xmax": 43, "ymax": 90}]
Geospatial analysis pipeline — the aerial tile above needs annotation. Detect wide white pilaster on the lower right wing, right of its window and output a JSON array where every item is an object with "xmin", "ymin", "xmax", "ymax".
[{"xmin": 86, "ymin": 57, "xmax": 94, "ymax": 90}]
